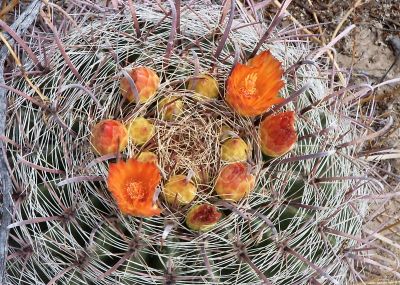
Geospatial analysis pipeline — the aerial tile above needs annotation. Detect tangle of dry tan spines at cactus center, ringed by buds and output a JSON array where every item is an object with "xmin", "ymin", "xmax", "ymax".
[{"xmin": 153, "ymin": 93, "xmax": 259, "ymax": 191}]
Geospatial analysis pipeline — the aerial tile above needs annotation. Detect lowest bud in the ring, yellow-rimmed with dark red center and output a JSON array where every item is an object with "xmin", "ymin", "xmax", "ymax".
[{"xmin": 186, "ymin": 204, "xmax": 222, "ymax": 232}]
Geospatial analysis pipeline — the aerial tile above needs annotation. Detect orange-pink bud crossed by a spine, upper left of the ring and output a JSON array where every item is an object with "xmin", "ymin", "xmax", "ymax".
[{"xmin": 120, "ymin": 66, "xmax": 160, "ymax": 103}]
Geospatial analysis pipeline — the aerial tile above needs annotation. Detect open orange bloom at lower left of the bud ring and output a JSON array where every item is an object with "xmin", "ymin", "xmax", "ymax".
[{"xmin": 108, "ymin": 158, "xmax": 161, "ymax": 217}]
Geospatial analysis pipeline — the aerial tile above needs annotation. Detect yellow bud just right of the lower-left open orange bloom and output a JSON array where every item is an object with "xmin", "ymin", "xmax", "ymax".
[{"xmin": 163, "ymin": 175, "xmax": 197, "ymax": 205}]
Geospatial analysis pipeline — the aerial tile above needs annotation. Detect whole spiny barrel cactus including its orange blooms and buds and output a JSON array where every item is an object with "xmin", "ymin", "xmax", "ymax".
[{"xmin": 6, "ymin": 1, "xmax": 380, "ymax": 284}]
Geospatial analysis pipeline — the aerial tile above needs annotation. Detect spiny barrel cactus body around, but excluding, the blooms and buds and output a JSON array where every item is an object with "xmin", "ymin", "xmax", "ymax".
[{"xmin": 3, "ymin": 1, "xmax": 379, "ymax": 284}]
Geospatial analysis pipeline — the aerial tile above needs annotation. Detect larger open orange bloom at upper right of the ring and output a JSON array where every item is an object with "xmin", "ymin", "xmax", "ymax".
[{"xmin": 226, "ymin": 51, "xmax": 284, "ymax": 117}]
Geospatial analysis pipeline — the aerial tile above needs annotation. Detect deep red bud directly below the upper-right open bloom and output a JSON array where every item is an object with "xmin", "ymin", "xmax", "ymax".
[{"xmin": 259, "ymin": 111, "xmax": 297, "ymax": 157}]
